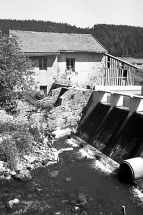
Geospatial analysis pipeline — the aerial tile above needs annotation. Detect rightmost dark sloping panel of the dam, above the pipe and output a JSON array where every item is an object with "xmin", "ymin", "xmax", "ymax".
[{"xmin": 107, "ymin": 113, "xmax": 143, "ymax": 162}]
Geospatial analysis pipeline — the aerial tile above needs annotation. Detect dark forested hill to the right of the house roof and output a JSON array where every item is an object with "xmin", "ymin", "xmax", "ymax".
[{"xmin": 90, "ymin": 24, "xmax": 143, "ymax": 58}]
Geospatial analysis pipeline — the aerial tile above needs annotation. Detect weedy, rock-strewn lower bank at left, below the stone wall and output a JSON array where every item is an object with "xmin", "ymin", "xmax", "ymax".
[{"xmin": 0, "ymin": 111, "xmax": 64, "ymax": 181}]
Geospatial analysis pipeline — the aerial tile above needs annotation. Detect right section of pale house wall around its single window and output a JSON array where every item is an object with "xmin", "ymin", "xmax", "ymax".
[{"xmin": 56, "ymin": 53, "xmax": 104, "ymax": 88}]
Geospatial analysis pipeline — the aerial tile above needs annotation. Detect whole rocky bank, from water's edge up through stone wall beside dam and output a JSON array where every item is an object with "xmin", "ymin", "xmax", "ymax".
[{"xmin": 0, "ymin": 88, "xmax": 91, "ymax": 183}]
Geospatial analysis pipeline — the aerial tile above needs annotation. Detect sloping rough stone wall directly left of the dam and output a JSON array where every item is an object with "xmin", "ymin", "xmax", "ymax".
[{"xmin": 47, "ymin": 88, "xmax": 92, "ymax": 131}]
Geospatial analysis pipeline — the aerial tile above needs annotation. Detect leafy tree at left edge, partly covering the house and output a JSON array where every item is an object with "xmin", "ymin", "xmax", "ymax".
[{"xmin": 0, "ymin": 33, "xmax": 34, "ymax": 110}]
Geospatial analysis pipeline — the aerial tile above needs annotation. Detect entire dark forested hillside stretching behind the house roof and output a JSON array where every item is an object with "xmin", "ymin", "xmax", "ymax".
[{"xmin": 0, "ymin": 19, "xmax": 143, "ymax": 58}]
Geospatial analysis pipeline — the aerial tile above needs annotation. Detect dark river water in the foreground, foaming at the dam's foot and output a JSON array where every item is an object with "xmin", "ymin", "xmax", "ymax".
[{"xmin": 0, "ymin": 139, "xmax": 143, "ymax": 215}]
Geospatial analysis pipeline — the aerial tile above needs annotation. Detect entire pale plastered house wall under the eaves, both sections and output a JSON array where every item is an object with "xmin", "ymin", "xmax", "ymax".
[{"xmin": 31, "ymin": 52, "xmax": 104, "ymax": 92}]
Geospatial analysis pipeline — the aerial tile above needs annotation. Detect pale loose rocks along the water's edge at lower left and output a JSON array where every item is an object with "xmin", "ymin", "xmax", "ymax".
[{"xmin": 0, "ymin": 141, "xmax": 59, "ymax": 181}]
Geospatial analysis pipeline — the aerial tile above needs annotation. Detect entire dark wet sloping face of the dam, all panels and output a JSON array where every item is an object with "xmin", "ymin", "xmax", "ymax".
[{"xmin": 77, "ymin": 103, "xmax": 143, "ymax": 163}]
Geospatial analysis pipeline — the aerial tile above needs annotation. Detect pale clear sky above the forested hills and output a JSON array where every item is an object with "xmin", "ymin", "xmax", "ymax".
[{"xmin": 0, "ymin": 0, "xmax": 143, "ymax": 28}]
